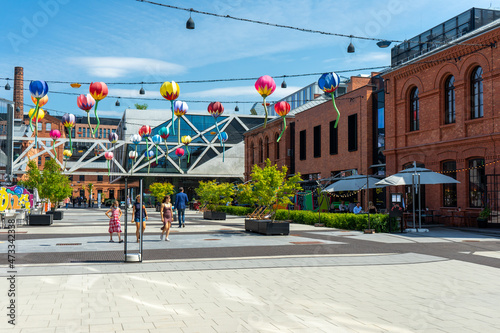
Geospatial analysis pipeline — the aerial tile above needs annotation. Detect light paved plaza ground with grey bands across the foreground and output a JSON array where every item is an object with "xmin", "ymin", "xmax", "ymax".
[{"xmin": 0, "ymin": 209, "xmax": 500, "ymax": 333}]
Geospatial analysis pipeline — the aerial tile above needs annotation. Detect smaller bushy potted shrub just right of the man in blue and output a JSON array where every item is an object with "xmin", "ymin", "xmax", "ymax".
[{"xmin": 196, "ymin": 180, "xmax": 234, "ymax": 220}]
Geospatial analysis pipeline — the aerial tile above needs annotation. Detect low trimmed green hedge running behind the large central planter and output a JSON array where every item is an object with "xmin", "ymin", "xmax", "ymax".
[{"xmin": 217, "ymin": 206, "xmax": 399, "ymax": 232}]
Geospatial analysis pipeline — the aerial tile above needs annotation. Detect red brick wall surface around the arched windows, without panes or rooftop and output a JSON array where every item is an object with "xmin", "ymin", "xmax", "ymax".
[{"xmin": 383, "ymin": 28, "xmax": 500, "ymax": 210}]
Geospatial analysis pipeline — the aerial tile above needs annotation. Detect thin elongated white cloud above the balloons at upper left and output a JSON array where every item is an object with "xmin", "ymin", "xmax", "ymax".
[{"xmin": 68, "ymin": 57, "xmax": 186, "ymax": 78}]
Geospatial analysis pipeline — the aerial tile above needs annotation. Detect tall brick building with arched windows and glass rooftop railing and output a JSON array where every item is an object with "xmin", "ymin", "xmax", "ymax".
[{"xmin": 383, "ymin": 8, "xmax": 500, "ymax": 218}]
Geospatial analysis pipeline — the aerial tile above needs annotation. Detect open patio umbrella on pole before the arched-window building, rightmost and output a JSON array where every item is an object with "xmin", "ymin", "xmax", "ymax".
[{"xmin": 376, "ymin": 166, "xmax": 460, "ymax": 228}]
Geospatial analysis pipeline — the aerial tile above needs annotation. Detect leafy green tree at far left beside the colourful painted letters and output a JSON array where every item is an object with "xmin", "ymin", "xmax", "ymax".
[{"xmin": 20, "ymin": 159, "xmax": 72, "ymax": 211}]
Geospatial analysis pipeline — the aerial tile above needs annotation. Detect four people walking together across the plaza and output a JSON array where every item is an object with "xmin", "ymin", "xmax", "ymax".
[{"xmin": 105, "ymin": 187, "xmax": 189, "ymax": 243}]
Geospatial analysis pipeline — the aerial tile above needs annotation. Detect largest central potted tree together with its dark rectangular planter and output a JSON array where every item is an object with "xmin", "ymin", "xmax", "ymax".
[{"xmin": 245, "ymin": 159, "xmax": 301, "ymax": 235}]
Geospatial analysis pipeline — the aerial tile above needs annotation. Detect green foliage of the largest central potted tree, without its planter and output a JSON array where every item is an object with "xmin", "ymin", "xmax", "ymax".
[{"xmin": 250, "ymin": 159, "xmax": 301, "ymax": 221}]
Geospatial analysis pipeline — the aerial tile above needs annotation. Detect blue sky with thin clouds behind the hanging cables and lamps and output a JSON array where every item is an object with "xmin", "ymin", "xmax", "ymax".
[{"xmin": 0, "ymin": 0, "xmax": 500, "ymax": 117}]
